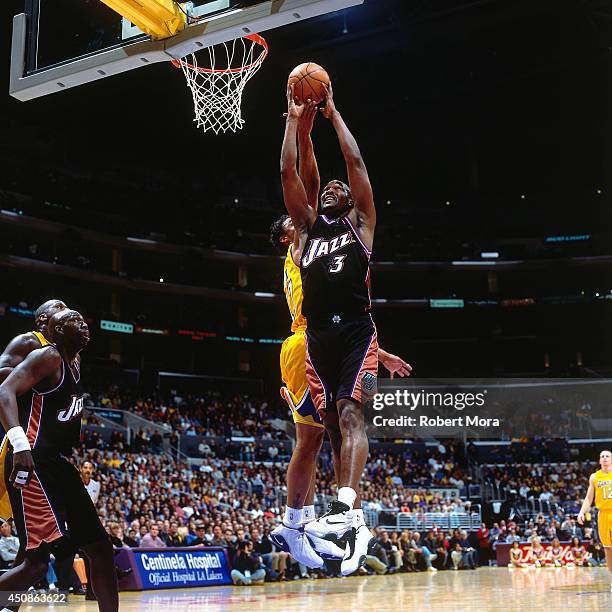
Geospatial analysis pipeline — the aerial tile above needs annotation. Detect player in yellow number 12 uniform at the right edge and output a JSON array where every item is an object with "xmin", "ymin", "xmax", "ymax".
[{"xmin": 578, "ymin": 450, "xmax": 612, "ymax": 593}]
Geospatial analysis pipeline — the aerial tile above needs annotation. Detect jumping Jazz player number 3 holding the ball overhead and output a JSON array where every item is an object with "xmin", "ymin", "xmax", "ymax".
[{"xmin": 281, "ymin": 86, "xmax": 378, "ymax": 575}]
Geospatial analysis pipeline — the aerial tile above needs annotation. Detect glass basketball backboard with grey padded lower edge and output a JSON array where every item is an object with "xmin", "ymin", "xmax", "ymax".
[{"xmin": 9, "ymin": 0, "xmax": 364, "ymax": 100}]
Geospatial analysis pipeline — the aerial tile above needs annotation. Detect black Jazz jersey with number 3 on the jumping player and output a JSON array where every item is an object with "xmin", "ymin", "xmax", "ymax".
[{"xmin": 300, "ymin": 215, "xmax": 371, "ymax": 323}]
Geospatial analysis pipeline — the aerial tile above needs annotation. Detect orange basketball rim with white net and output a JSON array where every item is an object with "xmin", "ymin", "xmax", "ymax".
[{"xmin": 172, "ymin": 34, "xmax": 268, "ymax": 134}]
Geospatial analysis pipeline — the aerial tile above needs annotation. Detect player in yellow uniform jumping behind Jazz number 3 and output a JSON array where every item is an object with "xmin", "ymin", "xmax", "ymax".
[{"xmin": 270, "ymin": 100, "xmax": 412, "ymax": 567}]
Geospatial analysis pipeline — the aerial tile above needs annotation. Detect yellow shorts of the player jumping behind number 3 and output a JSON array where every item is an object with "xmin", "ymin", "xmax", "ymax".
[{"xmin": 280, "ymin": 330, "xmax": 323, "ymax": 427}]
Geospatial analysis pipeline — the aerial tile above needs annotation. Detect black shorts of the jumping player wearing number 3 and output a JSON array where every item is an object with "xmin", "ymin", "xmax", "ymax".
[{"xmin": 306, "ymin": 315, "xmax": 378, "ymax": 420}]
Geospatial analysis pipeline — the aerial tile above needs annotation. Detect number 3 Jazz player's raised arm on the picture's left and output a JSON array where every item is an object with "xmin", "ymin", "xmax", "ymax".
[{"xmin": 281, "ymin": 86, "xmax": 316, "ymax": 232}]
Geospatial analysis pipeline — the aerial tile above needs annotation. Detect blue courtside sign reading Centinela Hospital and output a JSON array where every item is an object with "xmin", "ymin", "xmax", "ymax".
[{"xmin": 131, "ymin": 548, "xmax": 232, "ymax": 589}]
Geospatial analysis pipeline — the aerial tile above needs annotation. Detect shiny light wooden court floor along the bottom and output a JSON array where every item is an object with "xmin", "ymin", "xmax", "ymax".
[{"xmin": 64, "ymin": 567, "xmax": 612, "ymax": 612}]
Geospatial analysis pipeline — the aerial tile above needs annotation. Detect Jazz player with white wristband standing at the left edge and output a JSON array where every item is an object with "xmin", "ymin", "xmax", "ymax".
[{"xmin": 0, "ymin": 310, "xmax": 118, "ymax": 612}]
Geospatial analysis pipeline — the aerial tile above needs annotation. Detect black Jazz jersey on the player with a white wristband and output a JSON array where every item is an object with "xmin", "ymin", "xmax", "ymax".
[{"xmin": 17, "ymin": 345, "xmax": 83, "ymax": 458}]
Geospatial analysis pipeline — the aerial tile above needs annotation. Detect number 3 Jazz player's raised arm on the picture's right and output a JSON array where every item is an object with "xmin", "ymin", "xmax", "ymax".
[{"xmin": 321, "ymin": 83, "xmax": 376, "ymax": 238}]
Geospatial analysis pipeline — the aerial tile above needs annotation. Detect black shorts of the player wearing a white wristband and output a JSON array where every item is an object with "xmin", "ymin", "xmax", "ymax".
[{"xmin": 4, "ymin": 450, "xmax": 108, "ymax": 556}]
